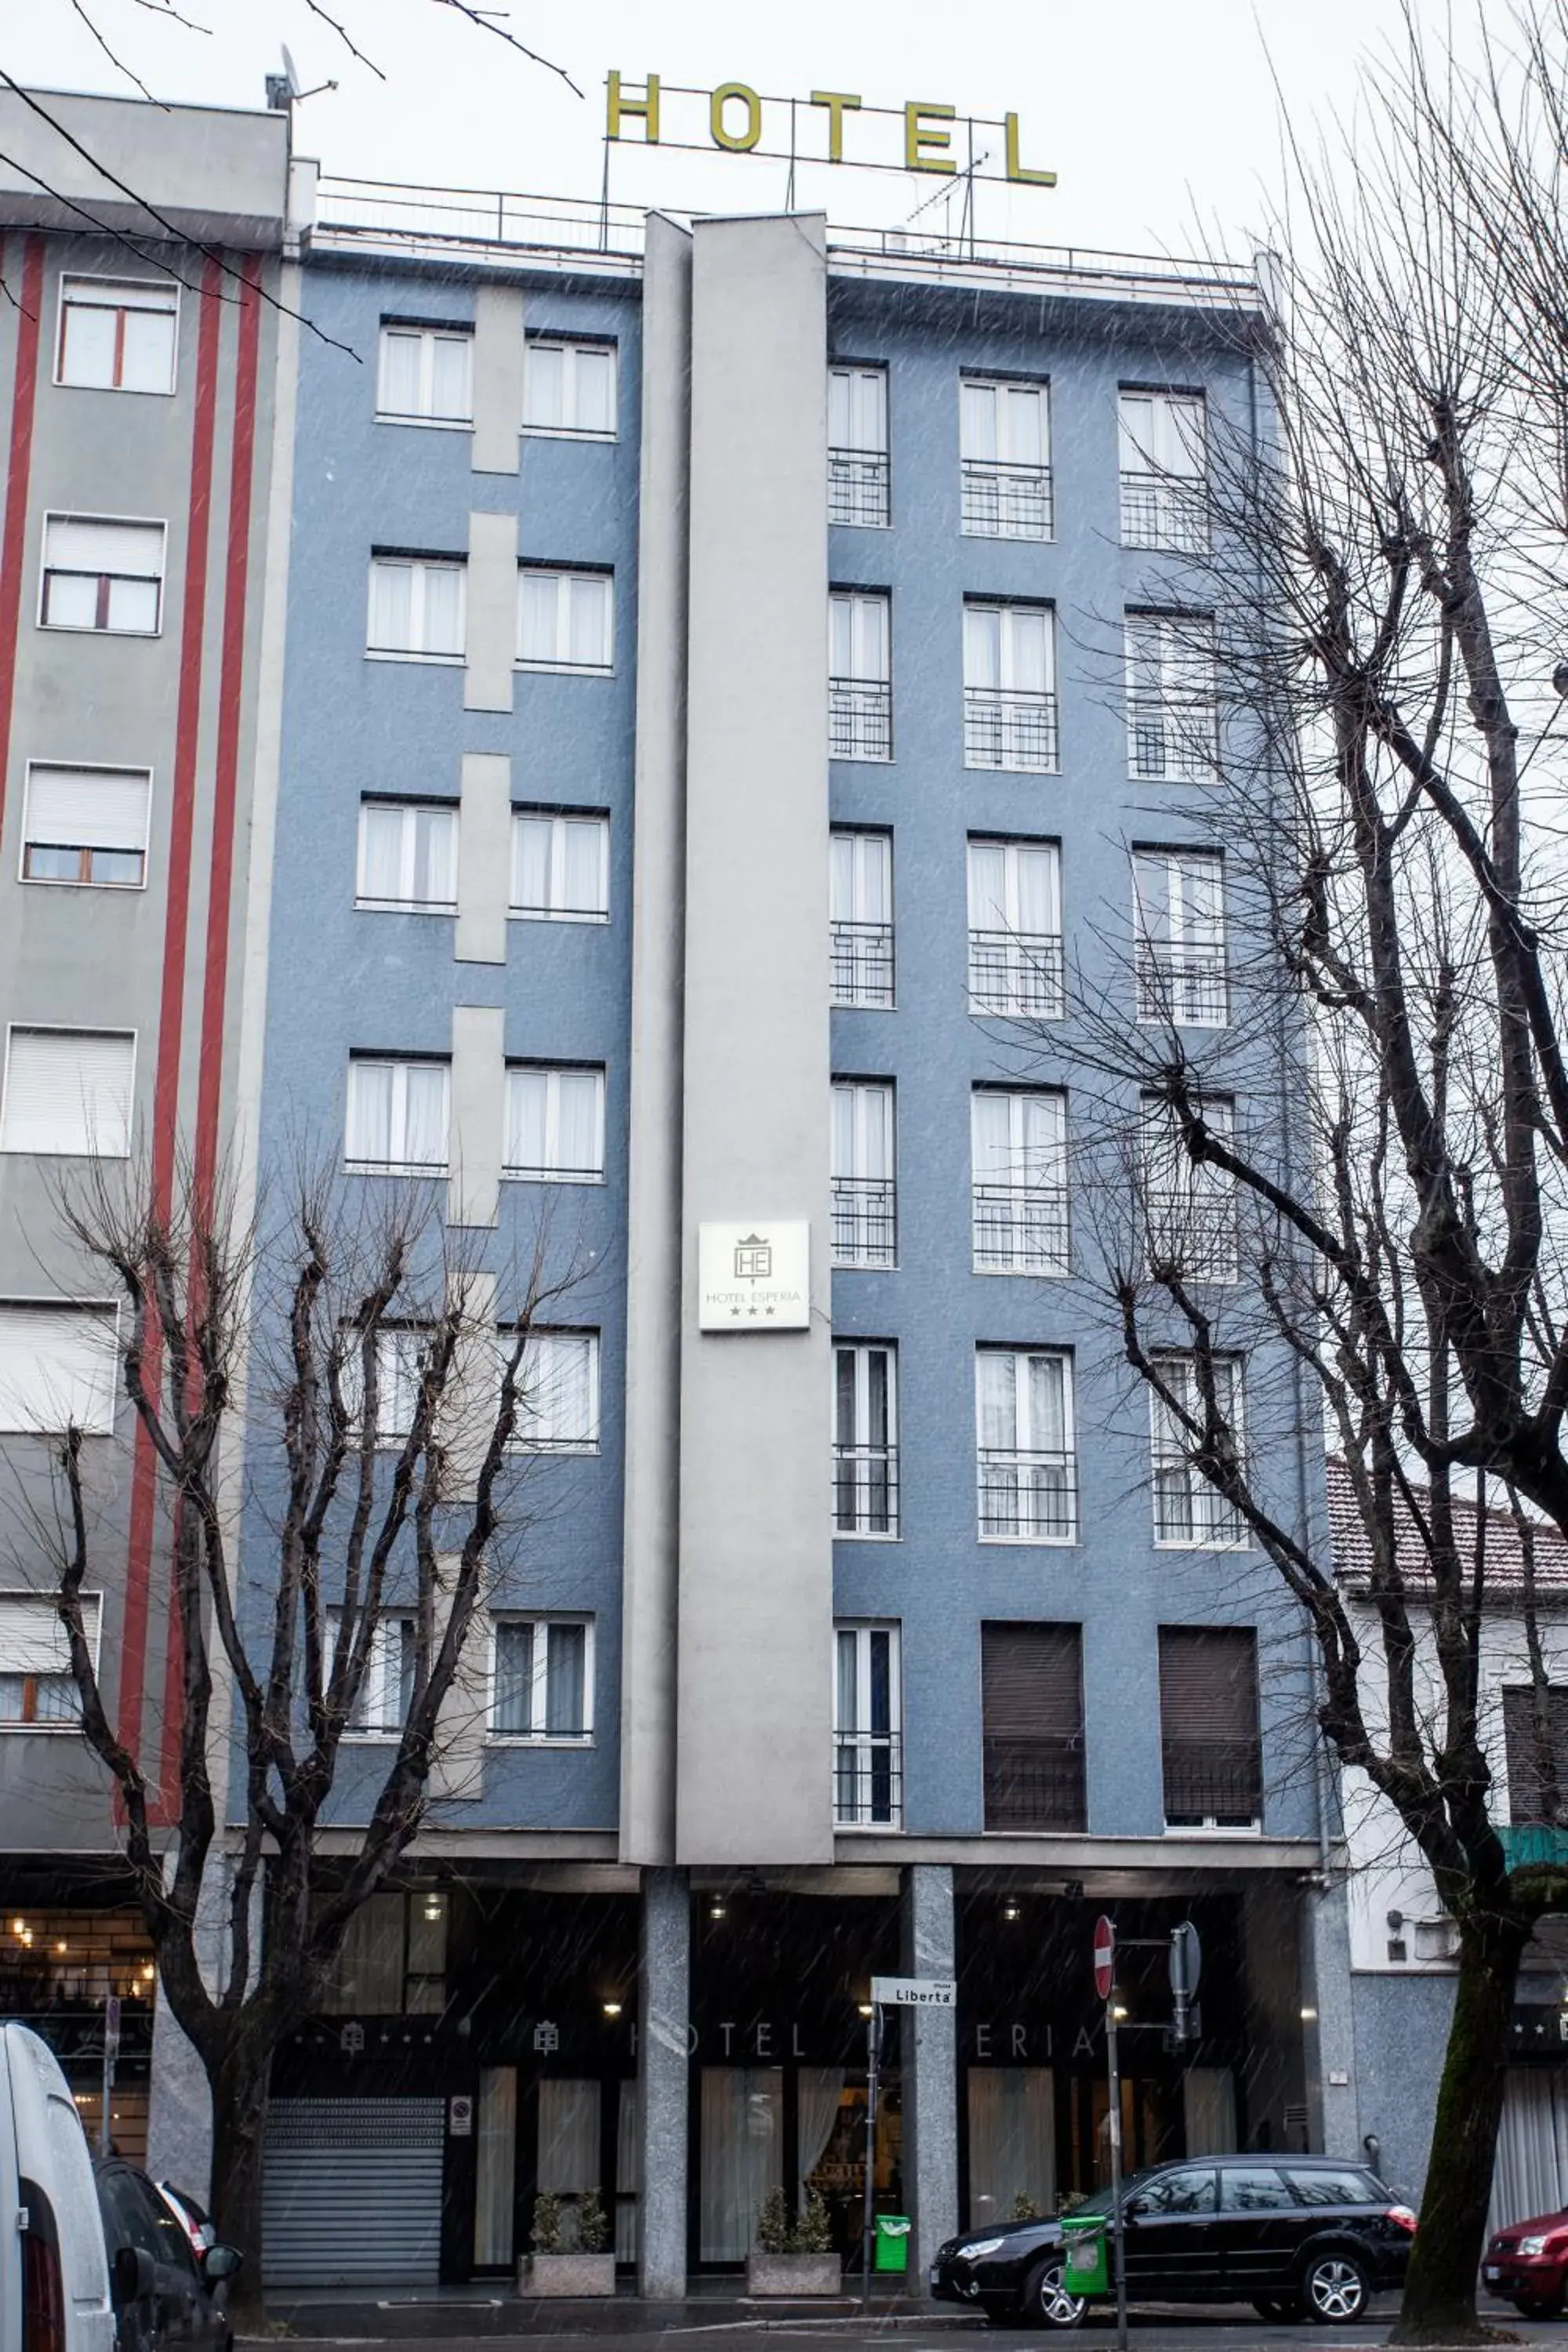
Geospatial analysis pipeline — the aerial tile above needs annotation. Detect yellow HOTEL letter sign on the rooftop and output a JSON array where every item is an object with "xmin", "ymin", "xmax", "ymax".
[{"xmin": 604, "ymin": 73, "xmax": 1055, "ymax": 188}]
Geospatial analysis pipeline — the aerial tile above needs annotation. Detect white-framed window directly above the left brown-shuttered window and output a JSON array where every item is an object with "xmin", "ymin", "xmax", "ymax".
[{"xmin": 975, "ymin": 1348, "xmax": 1079, "ymax": 1543}]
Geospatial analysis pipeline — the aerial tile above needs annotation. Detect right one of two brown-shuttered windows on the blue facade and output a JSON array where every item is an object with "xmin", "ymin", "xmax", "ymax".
[{"xmin": 1159, "ymin": 1625, "xmax": 1262, "ymax": 1830}]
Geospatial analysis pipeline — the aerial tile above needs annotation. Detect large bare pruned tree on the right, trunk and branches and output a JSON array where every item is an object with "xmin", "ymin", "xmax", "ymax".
[{"xmin": 1055, "ymin": 5, "xmax": 1568, "ymax": 2343}]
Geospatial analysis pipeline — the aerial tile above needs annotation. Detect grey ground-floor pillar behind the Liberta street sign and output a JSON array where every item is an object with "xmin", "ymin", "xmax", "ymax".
[{"xmin": 898, "ymin": 1863, "xmax": 959, "ymax": 2298}]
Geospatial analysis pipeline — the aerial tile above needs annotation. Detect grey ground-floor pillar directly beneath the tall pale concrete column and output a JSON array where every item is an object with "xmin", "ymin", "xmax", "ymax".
[{"xmin": 637, "ymin": 1870, "xmax": 691, "ymax": 2303}]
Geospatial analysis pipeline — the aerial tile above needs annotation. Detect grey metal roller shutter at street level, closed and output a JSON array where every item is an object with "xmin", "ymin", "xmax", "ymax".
[{"xmin": 261, "ymin": 2098, "xmax": 445, "ymax": 2286}]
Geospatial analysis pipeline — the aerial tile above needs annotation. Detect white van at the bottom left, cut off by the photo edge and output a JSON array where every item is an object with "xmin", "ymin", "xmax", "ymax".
[{"xmin": 0, "ymin": 2023, "xmax": 115, "ymax": 2352}]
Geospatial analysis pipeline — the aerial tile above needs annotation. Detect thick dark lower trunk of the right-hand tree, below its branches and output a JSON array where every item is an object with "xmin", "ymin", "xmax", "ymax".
[{"xmin": 1389, "ymin": 1919, "xmax": 1530, "ymax": 2345}]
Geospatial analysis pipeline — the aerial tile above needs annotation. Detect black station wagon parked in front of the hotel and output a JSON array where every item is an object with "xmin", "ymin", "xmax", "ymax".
[{"xmin": 928, "ymin": 2157, "xmax": 1415, "ymax": 2328}]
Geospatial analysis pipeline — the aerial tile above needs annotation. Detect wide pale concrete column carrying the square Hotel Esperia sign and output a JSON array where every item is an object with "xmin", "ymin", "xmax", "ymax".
[{"xmin": 677, "ymin": 214, "xmax": 832, "ymax": 1865}]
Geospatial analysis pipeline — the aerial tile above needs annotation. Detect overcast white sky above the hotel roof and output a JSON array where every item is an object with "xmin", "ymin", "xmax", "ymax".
[{"xmin": 0, "ymin": 0, "xmax": 1443, "ymax": 256}]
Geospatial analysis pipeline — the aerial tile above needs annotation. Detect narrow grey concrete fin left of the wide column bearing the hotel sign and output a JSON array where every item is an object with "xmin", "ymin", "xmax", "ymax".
[{"xmin": 621, "ymin": 212, "xmax": 691, "ymax": 1872}]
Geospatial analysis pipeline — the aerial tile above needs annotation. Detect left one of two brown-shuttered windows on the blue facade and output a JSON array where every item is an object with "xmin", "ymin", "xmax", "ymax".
[{"xmin": 980, "ymin": 1625, "xmax": 1086, "ymax": 1830}]
